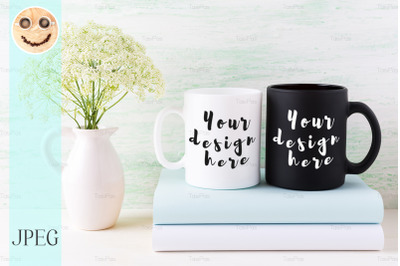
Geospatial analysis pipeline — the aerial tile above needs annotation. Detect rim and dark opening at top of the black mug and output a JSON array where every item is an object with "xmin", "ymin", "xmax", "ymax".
[{"xmin": 267, "ymin": 83, "xmax": 347, "ymax": 93}]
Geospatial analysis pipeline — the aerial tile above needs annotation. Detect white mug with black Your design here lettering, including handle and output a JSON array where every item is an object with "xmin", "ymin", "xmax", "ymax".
[{"xmin": 154, "ymin": 88, "xmax": 262, "ymax": 189}]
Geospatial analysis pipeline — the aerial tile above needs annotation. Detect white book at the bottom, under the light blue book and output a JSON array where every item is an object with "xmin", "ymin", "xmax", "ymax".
[{"xmin": 153, "ymin": 224, "xmax": 384, "ymax": 251}]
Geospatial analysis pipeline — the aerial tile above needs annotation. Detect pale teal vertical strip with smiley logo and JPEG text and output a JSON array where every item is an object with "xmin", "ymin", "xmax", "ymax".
[{"xmin": 9, "ymin": 0, "xmax": 61, "ymax": 266}]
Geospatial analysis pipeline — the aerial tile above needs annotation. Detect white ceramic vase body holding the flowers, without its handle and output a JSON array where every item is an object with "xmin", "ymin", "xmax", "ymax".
[{"xmin": 45, "ymin": 128, "xmax": 124, "ymax": 230}]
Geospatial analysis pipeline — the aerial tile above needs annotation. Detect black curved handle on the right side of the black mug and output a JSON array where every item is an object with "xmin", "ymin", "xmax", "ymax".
[{"xmin": 346, "ymin": 102, "xmax": 381, "ymax": 174}]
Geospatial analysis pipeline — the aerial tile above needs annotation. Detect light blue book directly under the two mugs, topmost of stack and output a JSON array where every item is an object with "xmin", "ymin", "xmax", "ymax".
[{"xmin": 153, "ymin": 169, "xmax": 384, "ymax": 224}]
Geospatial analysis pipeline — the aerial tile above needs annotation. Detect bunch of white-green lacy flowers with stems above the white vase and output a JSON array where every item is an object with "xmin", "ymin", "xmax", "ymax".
[{"xmin": 18, "ymin": 22, "xmax": 165, "ymax": 129}]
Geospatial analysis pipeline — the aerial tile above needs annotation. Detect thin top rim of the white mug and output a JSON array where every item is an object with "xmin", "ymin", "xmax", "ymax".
[{"xmin": 185, "ymin": 87, "xmax": 262, "ymax": 96}]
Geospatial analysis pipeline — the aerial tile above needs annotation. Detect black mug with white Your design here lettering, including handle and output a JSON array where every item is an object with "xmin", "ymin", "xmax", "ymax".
[{"xmin": 265, "ymin": 84, "xmax": 381, "ymax": 190}]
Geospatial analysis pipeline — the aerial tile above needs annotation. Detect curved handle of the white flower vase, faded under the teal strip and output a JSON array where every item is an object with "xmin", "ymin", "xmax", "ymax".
[{"xmin": 42, "ymin": 127, "xmax": 75, "ymax": 173}]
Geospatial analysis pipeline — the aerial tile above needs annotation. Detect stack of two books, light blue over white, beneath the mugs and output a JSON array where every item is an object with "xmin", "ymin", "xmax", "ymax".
[{"xmin": 153, "ymin": 169, "xmax": 384, "ymax": 251}]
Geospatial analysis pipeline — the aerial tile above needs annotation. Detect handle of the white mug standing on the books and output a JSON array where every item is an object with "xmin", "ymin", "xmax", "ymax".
[{"xmin": 153, "ymin": 107, "xmax": 185, "ymax": 169}]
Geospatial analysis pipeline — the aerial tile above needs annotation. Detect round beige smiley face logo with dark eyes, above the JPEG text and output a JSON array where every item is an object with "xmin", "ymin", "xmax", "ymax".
[{"xmin": 12, "ymin": 7, "xmax": 58, "ymax": 54}]
